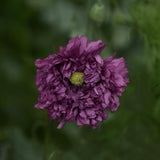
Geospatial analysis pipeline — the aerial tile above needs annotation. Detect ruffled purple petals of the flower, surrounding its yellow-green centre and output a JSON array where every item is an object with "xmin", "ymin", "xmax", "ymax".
[{"xmin": 35, "ymin": 36, "xmax": 129, "ymax": 129}]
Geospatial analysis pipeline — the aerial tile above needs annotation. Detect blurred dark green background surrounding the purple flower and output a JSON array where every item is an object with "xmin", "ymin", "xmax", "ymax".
[{"xmin": 0, "ymin": 0, "xmax": 160, "ymax": 160}]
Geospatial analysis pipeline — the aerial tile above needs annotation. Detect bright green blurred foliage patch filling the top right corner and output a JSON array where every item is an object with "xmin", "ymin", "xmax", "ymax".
[{"xmin": 131, "ymin": 1, "xmax": 160, "ymax": 47}]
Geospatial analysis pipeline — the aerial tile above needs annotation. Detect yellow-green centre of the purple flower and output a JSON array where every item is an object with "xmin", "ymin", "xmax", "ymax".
[{"xmin": 70, "ymin": 72, "xmax": 84, "ymax": 86}]
